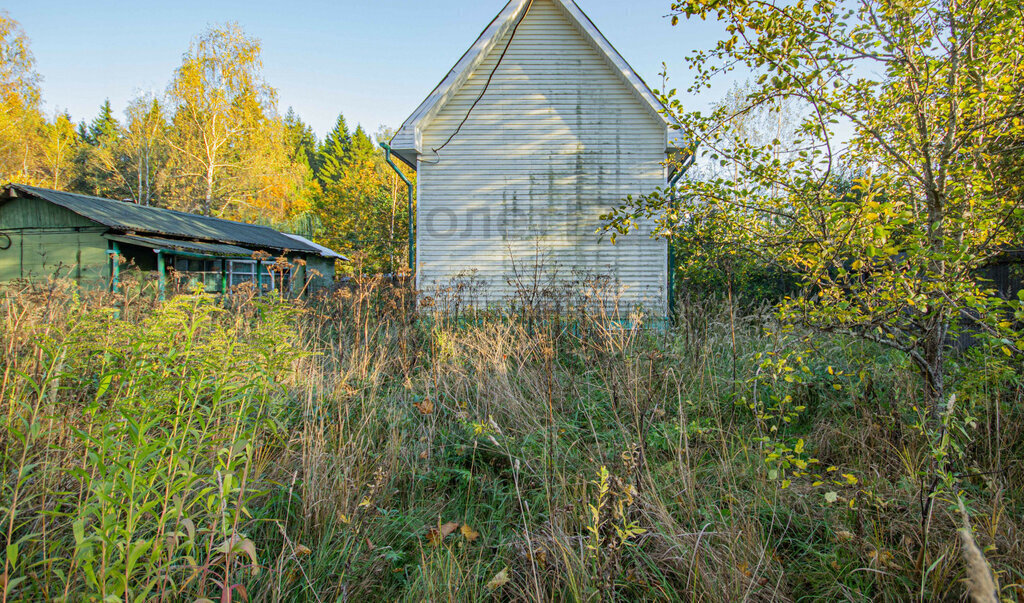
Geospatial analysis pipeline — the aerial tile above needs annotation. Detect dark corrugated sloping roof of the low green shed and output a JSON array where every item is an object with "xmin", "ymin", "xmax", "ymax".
[{"xmin": 7, "ymin": 184, "xmax": 339, "ymax": 257}]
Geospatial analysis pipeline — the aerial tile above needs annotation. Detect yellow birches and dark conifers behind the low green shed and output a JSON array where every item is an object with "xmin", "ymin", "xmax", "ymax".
[{"xmin": 0, "ymin": 13, "xmax": 412, "ymax": 272}]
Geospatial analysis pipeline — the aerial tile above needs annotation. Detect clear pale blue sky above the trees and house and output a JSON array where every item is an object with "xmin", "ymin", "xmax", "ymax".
[{"xmin": 3, "ymin": 0, "xmax": 722, "ymax": 135}]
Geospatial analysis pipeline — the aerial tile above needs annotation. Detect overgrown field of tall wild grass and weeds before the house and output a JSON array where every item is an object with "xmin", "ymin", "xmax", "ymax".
[{"xmin": 0, "ymin": 281, "xmax": 1024, "ymax": 601}]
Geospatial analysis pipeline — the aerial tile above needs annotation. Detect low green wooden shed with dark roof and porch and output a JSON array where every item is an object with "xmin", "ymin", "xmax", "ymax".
[{"xmin": 0, "ymin": 184, "xmax": 347, "ymax": 295}]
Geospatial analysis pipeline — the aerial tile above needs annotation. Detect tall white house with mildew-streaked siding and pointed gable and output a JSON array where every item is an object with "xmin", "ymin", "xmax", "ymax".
[{"xmin": 391, "ymin": 0, "xmax": 688, "ymax": 316}]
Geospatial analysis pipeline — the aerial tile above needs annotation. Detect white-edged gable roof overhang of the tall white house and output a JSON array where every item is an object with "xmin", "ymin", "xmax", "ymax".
[{"xmin": 390, "ymin": 0, "xmax": 682, "ymax": 169}]
